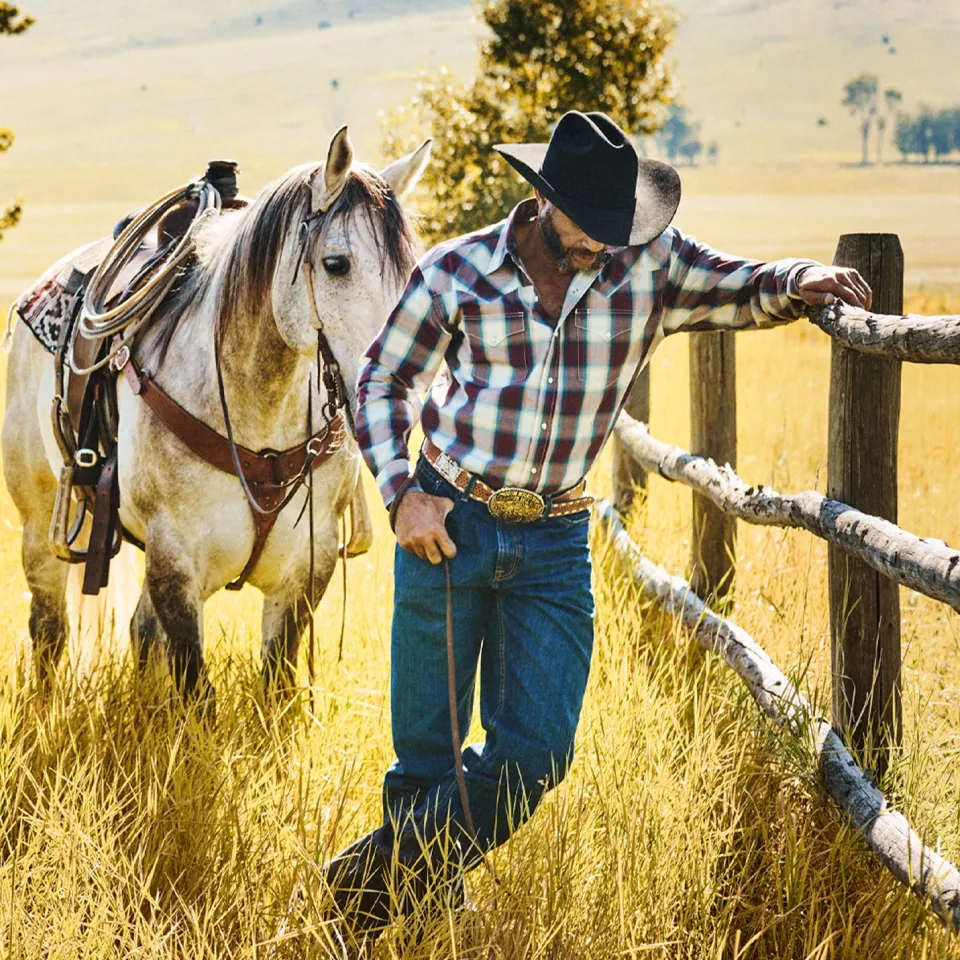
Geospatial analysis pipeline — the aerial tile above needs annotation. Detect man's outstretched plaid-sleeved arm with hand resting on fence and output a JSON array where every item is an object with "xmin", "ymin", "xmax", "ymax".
[{"xmin": 662, "ymin": 230, "xmax": 870, "ymax": 333}]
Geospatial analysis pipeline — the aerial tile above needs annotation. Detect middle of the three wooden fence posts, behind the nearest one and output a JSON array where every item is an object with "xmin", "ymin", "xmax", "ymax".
[{"xmin": 689, "ymin": 331, "xmax": 737, "ymax": 603}]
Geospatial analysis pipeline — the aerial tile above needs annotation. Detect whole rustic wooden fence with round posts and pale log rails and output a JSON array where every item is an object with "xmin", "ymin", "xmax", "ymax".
[{"xmin": 599, "ymin": 234, "xmax": 960, "ymax": 930}]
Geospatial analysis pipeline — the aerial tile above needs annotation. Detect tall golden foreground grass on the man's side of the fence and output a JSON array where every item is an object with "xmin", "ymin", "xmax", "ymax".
[{"xmin": 0, "ymin": 521, "xmax": 960, "ymax": 960}]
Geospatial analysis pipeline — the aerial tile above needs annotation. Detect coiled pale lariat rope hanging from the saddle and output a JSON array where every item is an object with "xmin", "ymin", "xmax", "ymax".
[{"xmin": 67, "ymin": 179, "xmax": 220, "ymax": 376}]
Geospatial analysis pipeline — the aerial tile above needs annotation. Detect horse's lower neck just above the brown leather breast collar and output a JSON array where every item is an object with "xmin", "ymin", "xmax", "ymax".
[{"xmin": 138, "ymin": 287, "xmax": 320, "ymax": 450}]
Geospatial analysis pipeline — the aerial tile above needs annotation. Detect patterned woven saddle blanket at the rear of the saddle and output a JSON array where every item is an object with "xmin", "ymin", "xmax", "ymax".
[{"xmin": 14, "ymin": 237, "xmax": 113, "ymax": 353}]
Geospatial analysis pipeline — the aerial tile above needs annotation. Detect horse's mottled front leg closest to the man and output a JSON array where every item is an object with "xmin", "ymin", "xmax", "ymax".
[{"xmin": 261, "ymin": 540, "xmax": 337, "ymax": 692}]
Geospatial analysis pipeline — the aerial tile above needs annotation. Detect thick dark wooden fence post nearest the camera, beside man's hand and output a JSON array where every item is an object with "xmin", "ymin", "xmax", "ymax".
[{"xmin": 827, "ymin": 233, "xmax": 903, "ymax": 774}]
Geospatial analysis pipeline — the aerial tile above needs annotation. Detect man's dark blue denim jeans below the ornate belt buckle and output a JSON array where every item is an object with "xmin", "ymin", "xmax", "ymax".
[{"xmin": 380, "ymin": 458, "xmax": 594, "ymax": 867}]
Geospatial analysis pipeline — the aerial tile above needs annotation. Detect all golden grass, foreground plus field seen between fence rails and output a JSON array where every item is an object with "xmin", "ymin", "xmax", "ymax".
[{"xmin": 0, "ymin": 294, "xmax": 960, "ymax": 960}]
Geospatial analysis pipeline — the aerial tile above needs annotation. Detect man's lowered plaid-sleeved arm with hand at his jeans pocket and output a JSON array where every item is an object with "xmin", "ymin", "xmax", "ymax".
[{"xmin": 357, "ymin": 267, "xmax": 457, "ymax": 563}]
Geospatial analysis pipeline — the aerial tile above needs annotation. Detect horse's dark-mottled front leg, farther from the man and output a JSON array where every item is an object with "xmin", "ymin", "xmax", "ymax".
[{"xmin": 146, "ymin": 529, "xmax": 215, "ymax": 715}]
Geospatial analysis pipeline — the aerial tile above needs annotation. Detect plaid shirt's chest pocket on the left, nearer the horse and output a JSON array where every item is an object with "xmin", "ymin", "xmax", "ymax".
[{"xmin": 460, "ymin": 301, "xmax": 530, "ymax": 387}]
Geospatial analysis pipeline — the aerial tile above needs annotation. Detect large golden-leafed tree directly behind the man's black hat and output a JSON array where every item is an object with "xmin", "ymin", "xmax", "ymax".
[{"xmin": 384, "ymin": 0, "xmax": 676, "ymax": 242}]
